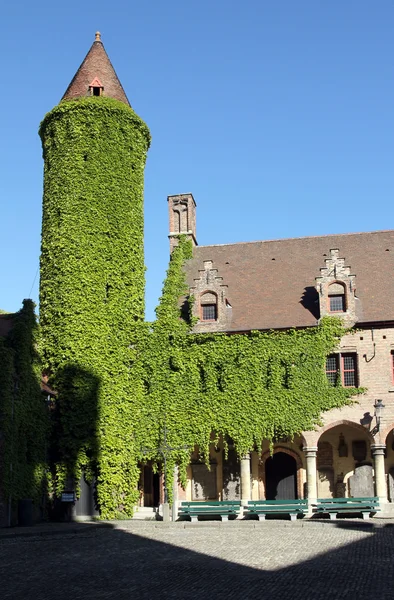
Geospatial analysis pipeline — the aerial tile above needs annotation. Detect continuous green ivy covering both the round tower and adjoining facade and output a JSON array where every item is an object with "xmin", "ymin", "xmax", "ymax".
[{"xmin": 40, "ymin": 97, "xmax": 357, "ymax": 518}]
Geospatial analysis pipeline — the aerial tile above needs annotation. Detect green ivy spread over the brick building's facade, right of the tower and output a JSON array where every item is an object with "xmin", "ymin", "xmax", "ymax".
[{"xmin": 136, "ymin": 239, "xmax": 364, "ymax": 500}]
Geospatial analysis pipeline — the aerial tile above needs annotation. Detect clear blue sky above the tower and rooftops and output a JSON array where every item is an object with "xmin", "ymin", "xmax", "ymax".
[{"xmin": 0, "ymin": 0, "xmax": 394, "ymax": 319}]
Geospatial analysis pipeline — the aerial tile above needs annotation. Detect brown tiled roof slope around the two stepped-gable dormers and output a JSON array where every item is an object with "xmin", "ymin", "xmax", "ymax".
[{"xmin": 186, "ymin": 231, "xmax": 394, "ymax": 331}]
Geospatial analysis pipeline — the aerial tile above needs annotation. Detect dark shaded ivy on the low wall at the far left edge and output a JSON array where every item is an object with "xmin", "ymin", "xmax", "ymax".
[{"xmin": 0, "ymin": 300, "xmax": 48, "ymax": 510}]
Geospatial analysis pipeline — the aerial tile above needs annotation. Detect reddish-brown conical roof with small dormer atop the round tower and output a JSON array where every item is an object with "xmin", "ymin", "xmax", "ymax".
[{"xmin": 62, "ymin": 32, "xmax": 130, "ymax": 106}]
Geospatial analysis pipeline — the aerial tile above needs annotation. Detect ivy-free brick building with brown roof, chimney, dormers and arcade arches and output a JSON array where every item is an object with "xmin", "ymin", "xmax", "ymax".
[{"xmin": 162, "ymin": 194, "xmax": 394, "ymax": 503}]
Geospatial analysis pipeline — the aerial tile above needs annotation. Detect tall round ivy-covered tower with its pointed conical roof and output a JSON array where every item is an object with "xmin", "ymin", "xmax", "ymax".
[{"xmin": 40, "ymin": 33, "xmax": 150, "ymax": 516}]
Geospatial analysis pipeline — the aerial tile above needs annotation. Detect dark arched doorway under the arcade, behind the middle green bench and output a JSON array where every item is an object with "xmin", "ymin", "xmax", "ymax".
[{"xmin": 265, "ymin": 452, "xmax": 297, "ymax": 500}]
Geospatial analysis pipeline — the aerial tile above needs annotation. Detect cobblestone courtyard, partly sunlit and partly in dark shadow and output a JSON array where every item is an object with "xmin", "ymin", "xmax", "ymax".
[{"xmin": 0, "ymin": 521, "xmax": 394, "ymax": 600}]
